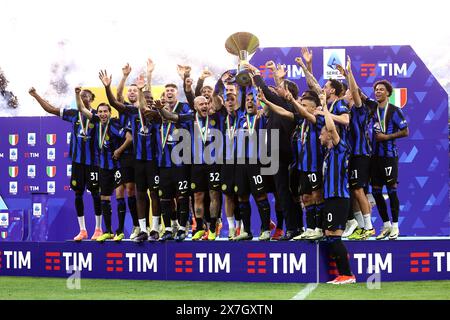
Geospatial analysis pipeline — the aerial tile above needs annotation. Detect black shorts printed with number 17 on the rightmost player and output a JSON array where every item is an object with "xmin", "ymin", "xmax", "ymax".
[{"xmin": 370, "ymin": 157, "xmax": 398, "ymax": 187}]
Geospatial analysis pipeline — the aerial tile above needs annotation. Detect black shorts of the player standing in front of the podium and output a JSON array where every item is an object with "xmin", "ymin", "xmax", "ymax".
[{"xmin": 322, "ymin": 198, "xmax": 350, "ymax": 231}]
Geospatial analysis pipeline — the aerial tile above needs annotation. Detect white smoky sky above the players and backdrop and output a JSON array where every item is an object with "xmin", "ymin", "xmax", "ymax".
[{"xmin": 0, "ymin": 0, "xmax": 450, "ymax": 116}]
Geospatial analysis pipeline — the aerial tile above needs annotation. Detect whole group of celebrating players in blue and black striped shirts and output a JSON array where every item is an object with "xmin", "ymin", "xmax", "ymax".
[{"xmin": 29, "ymin": 48, "xmax": 408, "ymax": 283}]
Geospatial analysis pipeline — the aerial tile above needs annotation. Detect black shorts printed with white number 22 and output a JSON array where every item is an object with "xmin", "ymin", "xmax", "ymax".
[{"xmin": 158, "ymin": 166, "xmax": 189, "ymax": 199}]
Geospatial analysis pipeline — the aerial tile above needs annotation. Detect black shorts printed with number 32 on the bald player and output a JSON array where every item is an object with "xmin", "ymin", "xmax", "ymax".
[{"xmin": 191, "ymin": 164, "xmax": 221, "ymax": 193}]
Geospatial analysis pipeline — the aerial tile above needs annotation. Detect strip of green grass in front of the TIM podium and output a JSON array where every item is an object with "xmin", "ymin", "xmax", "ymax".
[{"xmin": 0, "ymin": 277, "xmax": 450, "ymax": 300}]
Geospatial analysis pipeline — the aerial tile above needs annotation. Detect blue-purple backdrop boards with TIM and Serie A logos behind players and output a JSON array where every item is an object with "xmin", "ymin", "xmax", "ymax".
[{"xmin": 0, "ymin": 46, "xmax": 450, "ymax": 241}]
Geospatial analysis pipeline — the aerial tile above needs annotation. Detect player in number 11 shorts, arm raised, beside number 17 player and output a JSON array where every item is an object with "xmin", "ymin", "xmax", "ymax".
[{"xmin": 338, "ymin": 56, "xmax": 375, "ymax": 240}]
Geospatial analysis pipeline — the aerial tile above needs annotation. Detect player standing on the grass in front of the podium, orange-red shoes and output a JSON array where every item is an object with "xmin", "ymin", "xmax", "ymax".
[{"xmin": 319, "ymin": 94, "xmax": 356, "ymax": 284}]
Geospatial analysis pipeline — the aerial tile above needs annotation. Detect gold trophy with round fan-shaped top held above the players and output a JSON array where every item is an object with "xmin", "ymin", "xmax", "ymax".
[{"xmin": 225, "ymin": 32, "xmax": 259, "ymax": 87}]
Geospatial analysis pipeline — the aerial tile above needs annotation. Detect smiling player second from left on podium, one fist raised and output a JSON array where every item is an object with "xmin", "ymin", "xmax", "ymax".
[{"xmin": 75, "ymin": 87, "xmax": 132, "ymax": 242}]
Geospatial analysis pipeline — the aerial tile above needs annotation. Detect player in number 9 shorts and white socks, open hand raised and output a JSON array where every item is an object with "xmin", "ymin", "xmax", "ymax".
[{"xmin": 99, "ymin": 71, "xmax": 161, "ymax": 242}]
